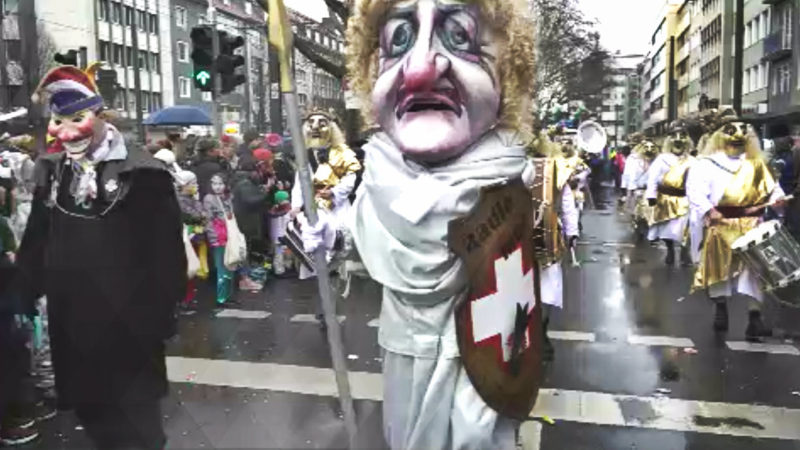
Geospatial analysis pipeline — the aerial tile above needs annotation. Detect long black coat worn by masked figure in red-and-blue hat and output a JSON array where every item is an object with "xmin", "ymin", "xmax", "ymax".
[{"xmin": 18, "ymin": 150, "xmax": 186, "ymax": 408}]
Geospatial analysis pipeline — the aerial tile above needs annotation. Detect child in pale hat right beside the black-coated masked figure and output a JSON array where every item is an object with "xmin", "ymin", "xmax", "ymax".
[{"xmin": 175, "ymin": 170, "xmax": 208, "ymax": 311}]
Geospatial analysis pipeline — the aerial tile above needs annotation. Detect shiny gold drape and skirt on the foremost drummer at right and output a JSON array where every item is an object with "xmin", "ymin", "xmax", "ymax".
[{"xmin": 692, "ymin": 158, "xmax": 775, "ymax": 291}]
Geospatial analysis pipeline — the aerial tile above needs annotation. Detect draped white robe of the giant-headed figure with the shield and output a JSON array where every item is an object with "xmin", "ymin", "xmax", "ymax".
[{"xmin": 351, "ymin": 131, "xmax": 527, "ymax": 450}]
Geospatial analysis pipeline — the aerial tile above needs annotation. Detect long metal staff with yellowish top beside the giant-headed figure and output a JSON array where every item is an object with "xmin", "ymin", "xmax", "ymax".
[{"xmin": 259, "ymin": 0, "xmax": 356, "ymax": 448}]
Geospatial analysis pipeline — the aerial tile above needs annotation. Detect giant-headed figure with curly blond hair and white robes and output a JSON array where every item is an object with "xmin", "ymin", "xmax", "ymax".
[{"xmin": 303, "ymin": 0, "xmax": 533, "ymax": 449}]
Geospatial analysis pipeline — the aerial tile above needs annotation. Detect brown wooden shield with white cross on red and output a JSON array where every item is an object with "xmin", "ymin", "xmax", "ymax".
[{"xmin": 448, "ymin": 179, "xmax": 542, "ymax": 420}]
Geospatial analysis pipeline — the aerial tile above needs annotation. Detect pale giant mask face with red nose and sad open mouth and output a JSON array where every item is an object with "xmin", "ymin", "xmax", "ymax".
[{"xmin": 372, "ymin": 0, "xmax": 501, "ymax": 162}]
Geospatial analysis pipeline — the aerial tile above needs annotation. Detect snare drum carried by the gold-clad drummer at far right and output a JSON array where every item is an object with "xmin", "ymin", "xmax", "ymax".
[{"xmin": 732, "ymin": 220, "xmax": 800, "ymax": 307}]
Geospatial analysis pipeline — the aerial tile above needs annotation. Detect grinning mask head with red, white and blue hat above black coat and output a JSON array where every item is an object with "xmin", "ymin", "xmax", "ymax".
[{"xmin": 34, "ymin": 66, "xmax": 105, "ymax": 158}]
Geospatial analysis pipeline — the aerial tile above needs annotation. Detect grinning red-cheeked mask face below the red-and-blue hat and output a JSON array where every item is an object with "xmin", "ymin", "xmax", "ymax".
[{"xmin": 47, "ymin": 109, "xmax": 103, "ymax": 157}]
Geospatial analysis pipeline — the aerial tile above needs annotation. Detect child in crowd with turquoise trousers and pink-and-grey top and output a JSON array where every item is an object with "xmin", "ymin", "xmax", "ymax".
[{"xmin": 203, "ymin": 173, "xmax": 235, "ymax": 307}]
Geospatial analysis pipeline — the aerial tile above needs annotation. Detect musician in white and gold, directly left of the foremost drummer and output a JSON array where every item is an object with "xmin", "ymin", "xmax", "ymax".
[{"xmin": 645, "ymin": 121, "xmax": 693, "ymax": 266}]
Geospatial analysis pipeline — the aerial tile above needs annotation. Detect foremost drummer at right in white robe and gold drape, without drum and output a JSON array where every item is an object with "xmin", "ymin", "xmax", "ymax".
[{"xmin": 686, "ymin": 110, "xmax": 785, "ymax": 341}]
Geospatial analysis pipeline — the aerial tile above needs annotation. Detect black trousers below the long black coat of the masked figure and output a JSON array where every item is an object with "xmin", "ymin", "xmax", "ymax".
[{"xmin": 75, "ymin": 400, "xmax": 167, "ymax": 450}]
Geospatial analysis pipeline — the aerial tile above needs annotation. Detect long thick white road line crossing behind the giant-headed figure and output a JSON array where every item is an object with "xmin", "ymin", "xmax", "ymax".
[{"xmin": 167, "ymin": 357, "xmax": 800, "ymax": 440}]
